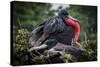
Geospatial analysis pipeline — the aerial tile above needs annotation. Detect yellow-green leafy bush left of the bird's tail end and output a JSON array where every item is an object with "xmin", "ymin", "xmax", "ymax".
[{"xmin": 14, "ymin": 29, "xmax": 29, "ymax": 65}]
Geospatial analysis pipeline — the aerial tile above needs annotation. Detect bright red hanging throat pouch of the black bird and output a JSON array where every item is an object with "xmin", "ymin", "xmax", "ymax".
[{"xmin": 64, "ymin": 17, "xmax": 80, "ymax": 47}]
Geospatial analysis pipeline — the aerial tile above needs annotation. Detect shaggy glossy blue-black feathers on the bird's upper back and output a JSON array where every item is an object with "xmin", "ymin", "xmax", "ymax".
[{"xmin": 43, "ymin": 17, "xmax": 66, "ymax": 33}]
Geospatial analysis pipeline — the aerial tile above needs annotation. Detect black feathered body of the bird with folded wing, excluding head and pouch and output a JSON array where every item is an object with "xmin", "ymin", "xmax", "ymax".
[{"xmin": 29, "ymin": 17, "xmax": 74, "ymax": 48}]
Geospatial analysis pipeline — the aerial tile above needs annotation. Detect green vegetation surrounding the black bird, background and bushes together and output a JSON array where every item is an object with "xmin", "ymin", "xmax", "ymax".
[{"xmin": 12, "ymin": 2, "xmax": 97, "ymax": 65}]
